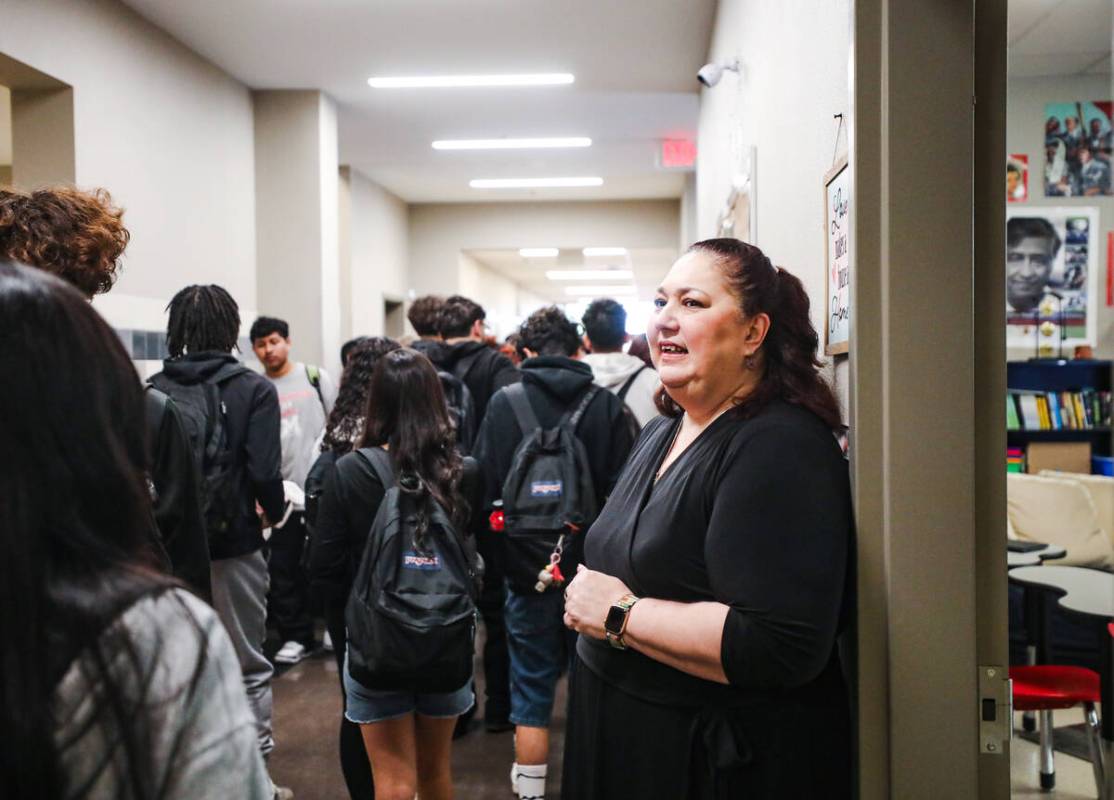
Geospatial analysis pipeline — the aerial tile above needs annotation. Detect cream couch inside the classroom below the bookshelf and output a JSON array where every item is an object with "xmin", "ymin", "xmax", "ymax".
[{"xmin": 1006, "ymin": 472, "xmax": 1114, "ymax": 570}]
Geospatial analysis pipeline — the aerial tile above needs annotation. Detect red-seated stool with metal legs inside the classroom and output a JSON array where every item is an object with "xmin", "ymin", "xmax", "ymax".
[{"xmin": 1009, "ymin": 664, "xmax": 1103, "ymax": 797}]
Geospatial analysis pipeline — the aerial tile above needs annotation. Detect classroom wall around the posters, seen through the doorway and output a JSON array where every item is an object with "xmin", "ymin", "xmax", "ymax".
[{"xmin": 1003, "ymin": 75, "xmax": 1114, "ymax": 359}]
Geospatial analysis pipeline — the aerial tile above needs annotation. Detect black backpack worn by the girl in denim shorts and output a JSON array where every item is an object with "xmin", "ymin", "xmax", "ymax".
[{"xmin": 344, "ymin": 447, "xmax": 478, "ymax": 692}]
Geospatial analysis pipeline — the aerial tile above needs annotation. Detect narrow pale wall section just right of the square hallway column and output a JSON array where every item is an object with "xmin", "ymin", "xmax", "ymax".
[{"xmin": 342, "ymin": 168, "xmax": 412, "ymax": 338}]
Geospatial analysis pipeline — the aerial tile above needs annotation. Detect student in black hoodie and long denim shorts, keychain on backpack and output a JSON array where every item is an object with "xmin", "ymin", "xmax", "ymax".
[{"xmin": 476, "ymin": 306, "xmax": 633, "ymax": 799}]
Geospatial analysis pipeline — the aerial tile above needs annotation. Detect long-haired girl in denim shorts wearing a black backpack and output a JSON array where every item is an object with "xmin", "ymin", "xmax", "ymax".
[{"xmin": 310, "ymin": 348, "xmax": 479, "ymax": 800}]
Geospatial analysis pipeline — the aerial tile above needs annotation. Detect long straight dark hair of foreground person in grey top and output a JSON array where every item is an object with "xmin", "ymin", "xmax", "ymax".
[{"xmin": 0, "ymin": 262, "xmax": 193, "ymax": 800}]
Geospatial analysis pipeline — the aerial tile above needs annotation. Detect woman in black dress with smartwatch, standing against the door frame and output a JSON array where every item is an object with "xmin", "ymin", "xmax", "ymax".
[{"xmin": 561, "ymin": 240, "xmax": 853, "ymax": 800}]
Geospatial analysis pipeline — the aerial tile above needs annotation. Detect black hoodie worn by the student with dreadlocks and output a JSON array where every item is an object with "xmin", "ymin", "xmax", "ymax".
[{"xmin": 152, "ymin": 352, "xmax": 284, "ymax": 560}]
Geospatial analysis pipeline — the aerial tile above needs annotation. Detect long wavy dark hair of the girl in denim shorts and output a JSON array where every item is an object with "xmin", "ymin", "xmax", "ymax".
[{"xmin": 360, "ymin": 348, "xmax": 468, "ymax": 539}]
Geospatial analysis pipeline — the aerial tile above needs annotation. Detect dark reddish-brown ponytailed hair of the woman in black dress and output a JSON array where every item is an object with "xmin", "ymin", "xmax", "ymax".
[{"xmin": 655, "ymin": 238, "xmax": 843, "ymax": 431}]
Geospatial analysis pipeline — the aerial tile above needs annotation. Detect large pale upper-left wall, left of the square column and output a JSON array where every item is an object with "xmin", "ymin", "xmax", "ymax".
[{"xmin": 0, "ymin": 0, "xmax": 256, "ymax": 326}]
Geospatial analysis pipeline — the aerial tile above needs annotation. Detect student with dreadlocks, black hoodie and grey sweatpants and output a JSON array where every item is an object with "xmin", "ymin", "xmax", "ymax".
[{"xmin": 152, "ymin": 285, "xmax": 289, "ymax": 797}]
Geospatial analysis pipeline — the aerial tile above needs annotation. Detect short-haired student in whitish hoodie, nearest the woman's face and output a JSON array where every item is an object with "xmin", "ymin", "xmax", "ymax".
[{"xmin": 580, "ymin": 297, "xmax": 661, "ymax": 430}]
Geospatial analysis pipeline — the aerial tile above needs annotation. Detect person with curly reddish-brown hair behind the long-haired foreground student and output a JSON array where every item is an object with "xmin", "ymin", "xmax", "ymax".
[{"xmin": 0, "ymin": 186, "xmax": 211, "ymax": 598}]
